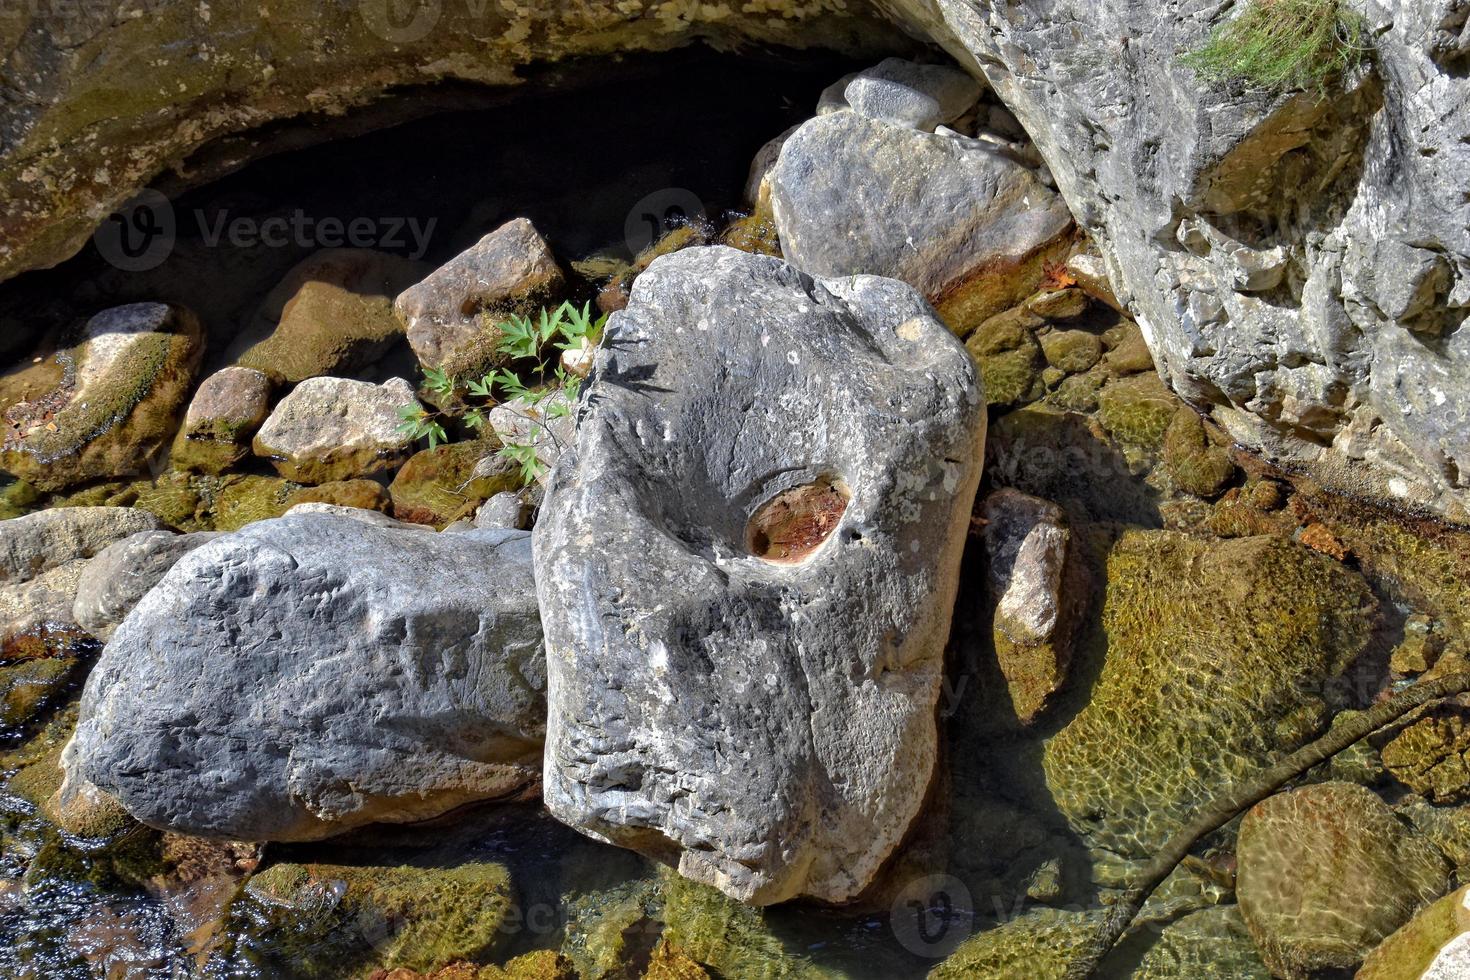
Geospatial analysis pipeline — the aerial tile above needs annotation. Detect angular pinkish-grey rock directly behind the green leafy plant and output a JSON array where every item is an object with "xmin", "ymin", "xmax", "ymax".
[{"xmin": 394, "ymin": 217, "xmax": 563, "ymax": 378}]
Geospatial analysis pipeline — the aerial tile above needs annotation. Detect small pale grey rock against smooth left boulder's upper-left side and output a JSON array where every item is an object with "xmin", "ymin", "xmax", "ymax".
[{"xmin": 72, "ymin": 530, "xmax": 219, "ymax": 641}]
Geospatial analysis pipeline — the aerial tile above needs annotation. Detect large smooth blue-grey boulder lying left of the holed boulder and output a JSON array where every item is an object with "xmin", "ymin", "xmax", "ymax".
[{"xmin": 62, "ymin": 513, "xmax": 545, "ymax": 840}]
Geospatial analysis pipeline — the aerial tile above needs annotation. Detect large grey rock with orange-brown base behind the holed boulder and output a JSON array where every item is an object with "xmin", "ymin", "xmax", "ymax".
[{"xmin": 767, "ymin": 73, "xmax": 1072, "ymax": 334}]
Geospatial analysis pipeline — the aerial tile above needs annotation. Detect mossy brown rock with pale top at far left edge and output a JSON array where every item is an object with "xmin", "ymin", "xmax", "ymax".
[{"xmin": 0, "ymin": 303, "xmax": 203, "ymax": 491}]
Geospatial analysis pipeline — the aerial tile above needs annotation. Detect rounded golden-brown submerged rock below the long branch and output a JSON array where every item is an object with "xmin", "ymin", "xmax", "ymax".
[{"xmin": 1236, "ymin": 783, "xmax": 1449, "ymax": 980}]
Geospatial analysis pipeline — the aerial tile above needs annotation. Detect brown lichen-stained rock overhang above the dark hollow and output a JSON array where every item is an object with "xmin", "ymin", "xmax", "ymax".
[{"xmin": 0, "ymin": 0, "xmax": 895, "ymax": 279}]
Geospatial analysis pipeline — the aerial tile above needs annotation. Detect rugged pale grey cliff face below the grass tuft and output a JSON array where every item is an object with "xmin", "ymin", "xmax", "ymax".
[{"xmin": 882, "ymin": 0, "xmax": 1470, "ymax": 522}]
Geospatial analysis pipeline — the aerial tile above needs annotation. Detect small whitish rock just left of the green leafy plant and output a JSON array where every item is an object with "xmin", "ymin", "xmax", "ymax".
[{"xmin": 254, "ymin": 378, "xmax": 419, "ymax": 483}]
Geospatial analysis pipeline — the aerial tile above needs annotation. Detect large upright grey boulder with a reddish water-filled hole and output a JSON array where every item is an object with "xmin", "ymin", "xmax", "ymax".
[{"xmin": 534, "ymin": 247, "xmax": 985, "ymax": 905}]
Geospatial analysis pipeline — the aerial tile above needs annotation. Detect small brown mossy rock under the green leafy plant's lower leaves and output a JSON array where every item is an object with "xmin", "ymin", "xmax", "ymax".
[{"xmin": 388, "ymin": 441, "xmax": 520, "ymax": 527}]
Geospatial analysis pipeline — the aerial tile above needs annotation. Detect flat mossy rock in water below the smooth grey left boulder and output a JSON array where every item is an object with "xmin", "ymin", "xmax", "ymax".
[{"xmin": 244, "ymin": 861, "xmax": 515, "ymax": 979}]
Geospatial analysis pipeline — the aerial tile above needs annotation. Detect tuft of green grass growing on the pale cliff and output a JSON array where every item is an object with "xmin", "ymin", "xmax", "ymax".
[{"xmin": 1180, "ymin": 0, "xmax": 1369, "ymax": 94}]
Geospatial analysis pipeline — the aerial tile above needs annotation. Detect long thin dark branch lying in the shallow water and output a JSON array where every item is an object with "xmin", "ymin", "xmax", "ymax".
[{"xmin": 1063, "ymin": 673, "xmax": 1470, "ymax": 980}]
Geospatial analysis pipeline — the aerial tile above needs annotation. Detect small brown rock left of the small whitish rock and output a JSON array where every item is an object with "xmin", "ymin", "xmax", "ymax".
[{"xmin": 169, "ymin": 367, "xmax": 270, "ymax": 475}]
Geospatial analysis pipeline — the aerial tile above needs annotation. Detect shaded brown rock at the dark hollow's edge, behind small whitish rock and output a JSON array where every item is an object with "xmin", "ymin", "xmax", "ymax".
[{"xmin": 231, "ymin": 248, "xmax": 428, "ymax": 383}]
